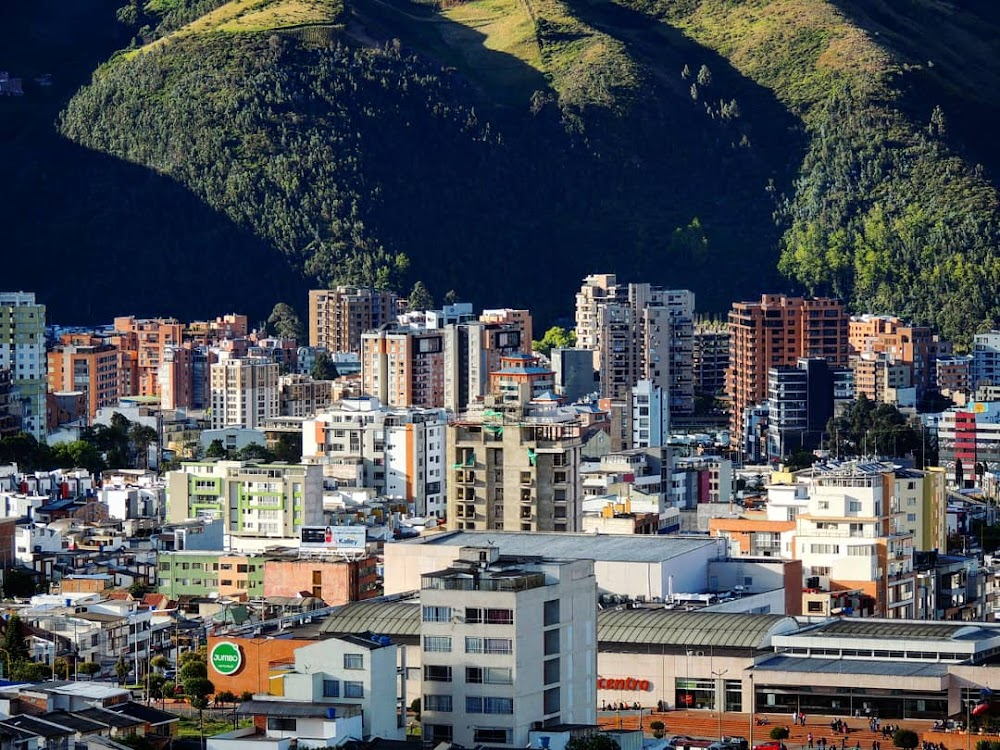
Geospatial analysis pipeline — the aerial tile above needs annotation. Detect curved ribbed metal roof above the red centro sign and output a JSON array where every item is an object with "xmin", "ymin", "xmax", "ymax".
[{"xmin": 597, "ymin": 609, "xmax": 798, "ymax": 649}]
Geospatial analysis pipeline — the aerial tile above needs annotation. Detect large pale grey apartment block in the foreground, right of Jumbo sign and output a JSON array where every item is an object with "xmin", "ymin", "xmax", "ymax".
[{"xmin": 420, "ymin": 546, "xmax": 597, "ymax": 747}]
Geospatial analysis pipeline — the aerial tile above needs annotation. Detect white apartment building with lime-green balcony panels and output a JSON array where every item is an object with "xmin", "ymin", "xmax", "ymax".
[{"xmin": 167, "ymin": 461, "xmax": 323, "ymax": 538}]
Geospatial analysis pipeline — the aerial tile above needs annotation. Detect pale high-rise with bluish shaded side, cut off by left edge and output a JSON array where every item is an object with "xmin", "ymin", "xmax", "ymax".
[{"xmin": 0, "ymin": 292, "xmax": 46, "ymax": 440}]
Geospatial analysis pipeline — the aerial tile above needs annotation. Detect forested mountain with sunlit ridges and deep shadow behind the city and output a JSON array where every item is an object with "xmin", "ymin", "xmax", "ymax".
[{"xmin": 0, "ymin": 0, "xmax": 1000, "ymax": 337}]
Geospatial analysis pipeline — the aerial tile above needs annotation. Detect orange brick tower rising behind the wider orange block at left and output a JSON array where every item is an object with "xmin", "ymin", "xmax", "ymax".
[{"xmin": 114, "ymin": 316, "xmax": 184, "ymax": 396}]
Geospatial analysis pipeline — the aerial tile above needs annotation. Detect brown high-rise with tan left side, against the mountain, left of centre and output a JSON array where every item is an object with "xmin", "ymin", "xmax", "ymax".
[{"xmin": 309, "ymin": 286, "xmax": 399, "ymax": 353}]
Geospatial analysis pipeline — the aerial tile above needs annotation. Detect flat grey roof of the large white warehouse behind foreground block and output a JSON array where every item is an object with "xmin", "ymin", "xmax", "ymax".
[{"xmin": 398, "ymin": 531, "xmax": 718, "ymax": 563}]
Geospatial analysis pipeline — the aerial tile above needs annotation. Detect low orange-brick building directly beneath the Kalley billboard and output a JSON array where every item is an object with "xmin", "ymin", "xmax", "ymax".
[{"xmin": 264, "ymin": 557, "xmax": 379, "ymax": 607}]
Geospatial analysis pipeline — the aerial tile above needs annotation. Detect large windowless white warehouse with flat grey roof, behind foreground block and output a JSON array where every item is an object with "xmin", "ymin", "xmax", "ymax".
[{"xmin": 384, "ymin": 531, "xmax": 727, "ymax": 602}]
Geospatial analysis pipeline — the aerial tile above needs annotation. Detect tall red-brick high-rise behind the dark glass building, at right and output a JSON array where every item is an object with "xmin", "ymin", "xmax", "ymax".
[{"xmin": 726, "ymin": 294, "xmax": 848, "ymax": 447}]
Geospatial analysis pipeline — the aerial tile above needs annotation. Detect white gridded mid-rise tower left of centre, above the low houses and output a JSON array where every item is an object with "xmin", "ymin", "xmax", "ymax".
[{"xmin": 210, "ymin": 359, "xmax": 281, "ymax": 430}]
